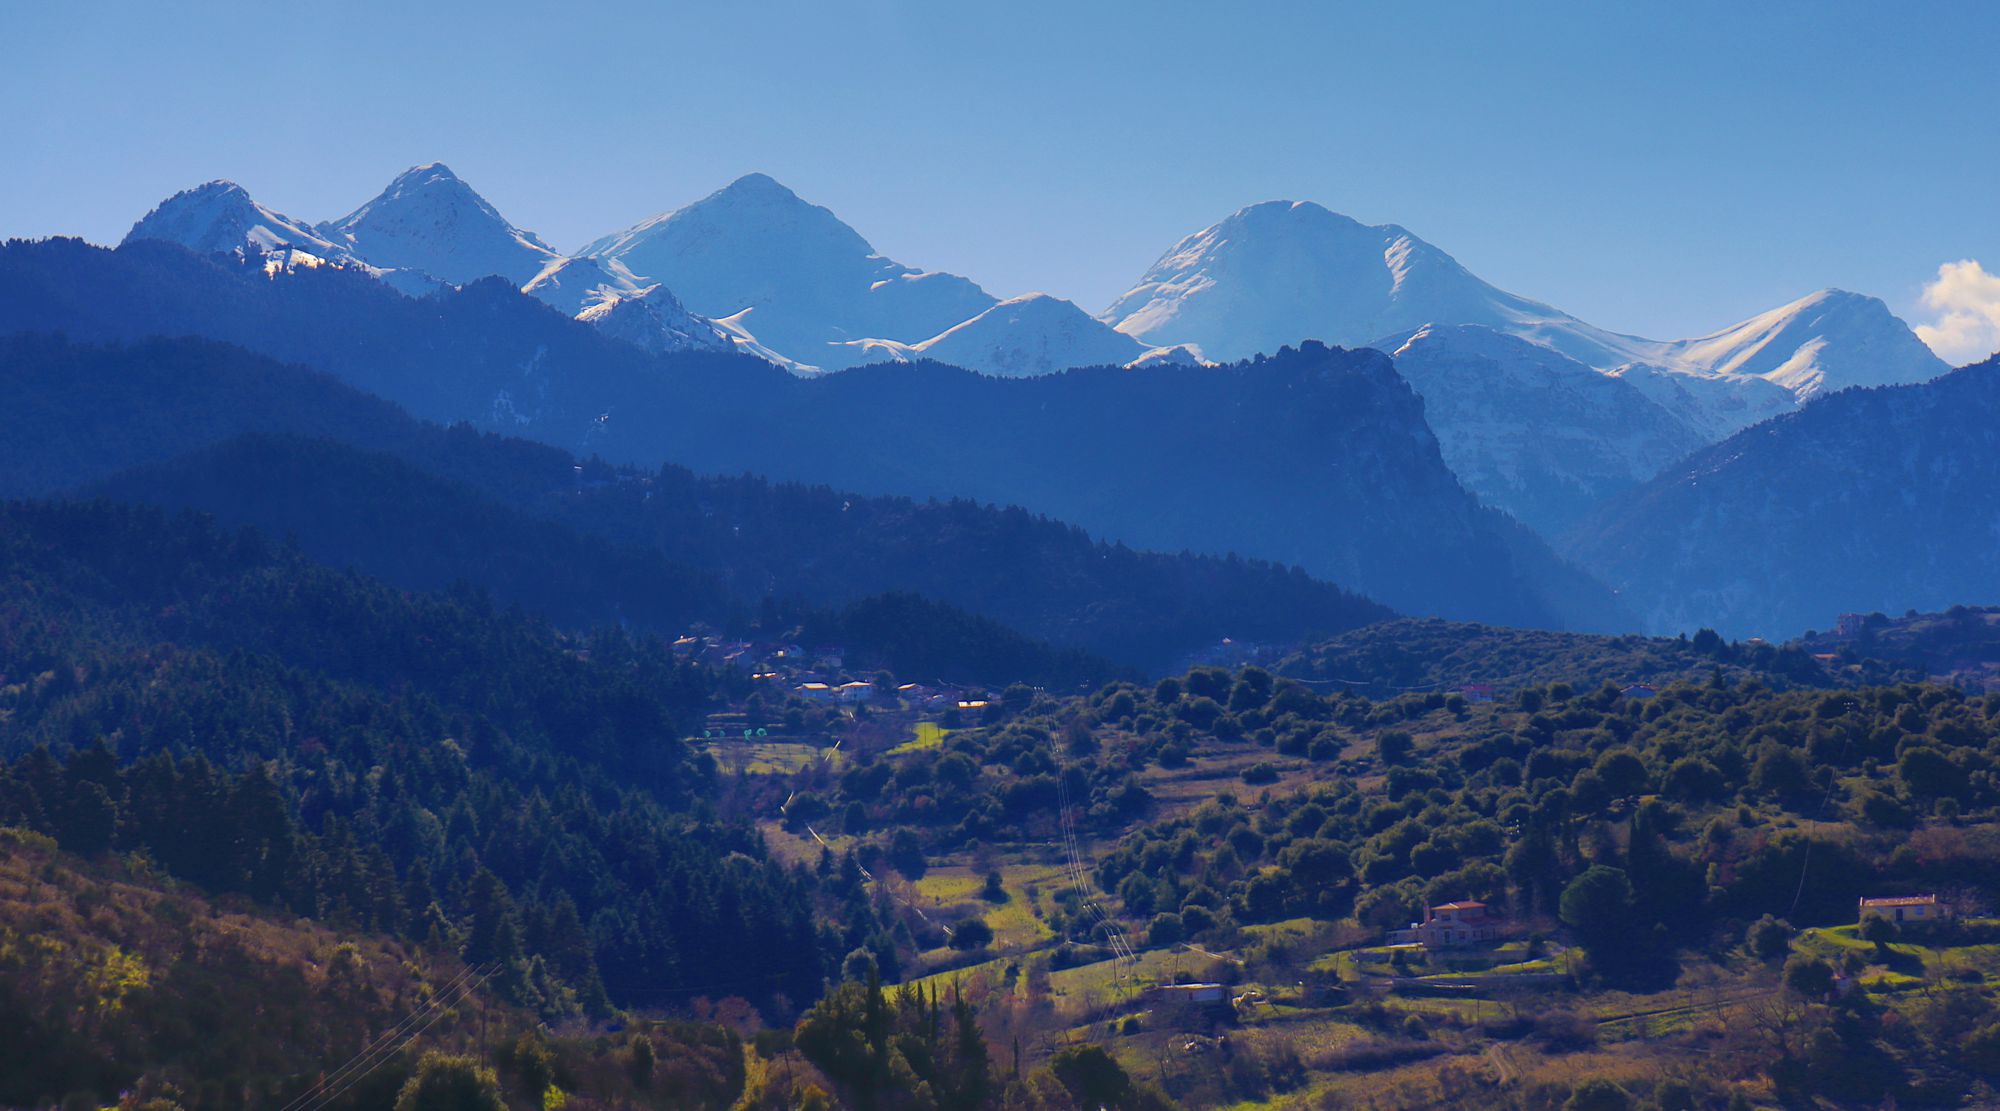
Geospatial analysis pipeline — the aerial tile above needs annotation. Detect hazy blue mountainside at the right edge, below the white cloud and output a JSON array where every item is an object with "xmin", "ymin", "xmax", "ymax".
[{"xmin": 1566, "ymin": 360, "xmax": 2000, "ymax": 639}]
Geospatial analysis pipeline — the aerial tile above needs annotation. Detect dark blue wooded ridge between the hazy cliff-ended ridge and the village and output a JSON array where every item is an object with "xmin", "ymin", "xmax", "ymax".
[{"xmin": 0, "ymin": 338, "xmax": 1388, "ymax": 681}]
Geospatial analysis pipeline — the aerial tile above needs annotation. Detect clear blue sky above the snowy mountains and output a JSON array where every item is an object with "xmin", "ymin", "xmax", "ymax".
[{"xmin": 0, "ymin": 0, "xmax": 2000, "ymax": 338}]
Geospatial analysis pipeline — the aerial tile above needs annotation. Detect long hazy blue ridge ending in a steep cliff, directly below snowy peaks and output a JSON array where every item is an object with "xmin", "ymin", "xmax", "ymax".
[{"xmin": 0, "ymin": 242, "xmax": 1620, "ymax": 627}]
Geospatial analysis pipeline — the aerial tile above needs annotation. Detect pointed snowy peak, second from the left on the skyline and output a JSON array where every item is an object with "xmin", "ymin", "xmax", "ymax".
[{"xmin": 318, "ymin": 162, "xmax": 558, "ymax": 286}]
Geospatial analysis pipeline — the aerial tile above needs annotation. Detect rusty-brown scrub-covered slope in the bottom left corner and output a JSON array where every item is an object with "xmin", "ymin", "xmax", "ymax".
[{"xmin": 0, "ymin": 829, "xmax": 508, "ymax": 1107}]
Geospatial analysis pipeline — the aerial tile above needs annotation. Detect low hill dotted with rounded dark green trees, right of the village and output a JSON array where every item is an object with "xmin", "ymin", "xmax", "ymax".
[{"xmin": 792, "ymin": 651, "xmax": 2000, "ymax": 991}]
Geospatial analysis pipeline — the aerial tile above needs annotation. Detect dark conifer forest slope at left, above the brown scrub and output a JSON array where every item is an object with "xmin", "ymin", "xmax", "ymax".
[{"xmin": 0, "ymin": 504, "xmax": 874, "ymax": 1013}]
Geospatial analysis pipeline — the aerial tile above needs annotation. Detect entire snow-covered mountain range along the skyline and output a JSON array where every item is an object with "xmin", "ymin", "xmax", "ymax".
[{"xmin": 128, "ymin": 162, "xmax": 1948, "ymax": 437}]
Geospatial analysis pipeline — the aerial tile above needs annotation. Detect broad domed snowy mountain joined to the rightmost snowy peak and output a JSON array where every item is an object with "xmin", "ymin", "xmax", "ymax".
[{"xmin": 1102, "ymin": 200, "xmax": 1946, "ymax": 438}]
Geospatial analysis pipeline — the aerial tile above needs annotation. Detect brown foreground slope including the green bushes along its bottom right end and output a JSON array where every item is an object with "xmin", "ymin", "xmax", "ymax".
[{"xmin": 0, "ymin": 829, "xmax": 772, "ymax": 1111}]
